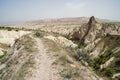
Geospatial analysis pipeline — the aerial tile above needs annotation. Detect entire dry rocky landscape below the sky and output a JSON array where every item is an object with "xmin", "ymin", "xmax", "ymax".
[{"xmin": 0, "ymin": 16, "xmax": 120, "ymax": 80}]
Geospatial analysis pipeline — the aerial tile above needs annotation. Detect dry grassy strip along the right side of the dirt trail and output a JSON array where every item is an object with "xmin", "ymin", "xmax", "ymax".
[{"xmin": 43, "ymin": 39, "xmax": 80, "ymax": 80}]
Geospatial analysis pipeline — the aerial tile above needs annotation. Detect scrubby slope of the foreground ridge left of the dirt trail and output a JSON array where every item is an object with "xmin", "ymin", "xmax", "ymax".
[{"xmin": 0, "ymin": 35, "xmax": 37, "ymax": 80}]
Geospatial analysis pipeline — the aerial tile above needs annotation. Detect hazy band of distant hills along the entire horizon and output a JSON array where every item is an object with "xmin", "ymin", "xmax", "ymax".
[{"xmin": 0, "ymin": 17, "xmax": 119, "ymax": 26}]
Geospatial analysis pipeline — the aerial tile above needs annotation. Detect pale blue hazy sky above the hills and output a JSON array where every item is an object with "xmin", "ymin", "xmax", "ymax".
[{"xmin": 0, "ymin": 0, "xmax": 120, "ymax": 24}]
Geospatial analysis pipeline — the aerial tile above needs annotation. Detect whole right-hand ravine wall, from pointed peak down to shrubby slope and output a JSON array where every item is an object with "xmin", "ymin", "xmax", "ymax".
[{"xmin": 71, "ymin": 16, "xmax": 120, "ymax": 80}]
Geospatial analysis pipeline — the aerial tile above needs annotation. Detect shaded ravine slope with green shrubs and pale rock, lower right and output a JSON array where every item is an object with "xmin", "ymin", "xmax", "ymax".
[{"xmin": 90, "ymin": 35, "xmax": 120, "ymax": 80}]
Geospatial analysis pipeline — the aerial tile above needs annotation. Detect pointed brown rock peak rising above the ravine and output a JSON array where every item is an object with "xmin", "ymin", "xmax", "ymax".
[{"xmin": 71, "ymin": 16, "xmax": 101, "ymax": 44}]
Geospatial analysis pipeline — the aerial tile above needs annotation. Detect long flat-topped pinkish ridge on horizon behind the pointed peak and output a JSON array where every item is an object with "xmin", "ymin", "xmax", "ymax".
[{"xmin": 26, "ymin": 17, "xmax": 115, "ymax": 24}]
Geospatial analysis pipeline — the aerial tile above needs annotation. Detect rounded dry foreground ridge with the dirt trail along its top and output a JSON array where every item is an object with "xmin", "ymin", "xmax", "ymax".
[{"xmin": 0, "ymin": 31, "xmax": 103, "ymax": 80}]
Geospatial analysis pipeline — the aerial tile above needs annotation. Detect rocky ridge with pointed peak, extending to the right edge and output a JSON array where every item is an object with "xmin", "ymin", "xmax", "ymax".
[{"xmin": 70, "ymin": 16, "xmax": 120, "ymax": 44}]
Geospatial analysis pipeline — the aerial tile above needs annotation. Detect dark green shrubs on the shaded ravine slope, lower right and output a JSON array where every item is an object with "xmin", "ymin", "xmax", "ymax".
[{"xmin": 86, "ymin": 35, "xmax": 120, "ymax": 79}]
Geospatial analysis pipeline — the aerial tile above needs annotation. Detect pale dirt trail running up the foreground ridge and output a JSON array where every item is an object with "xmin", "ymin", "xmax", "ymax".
[{"xmin": 27, "ymin": 39, "xmax": 64, "ymax": 80}]
